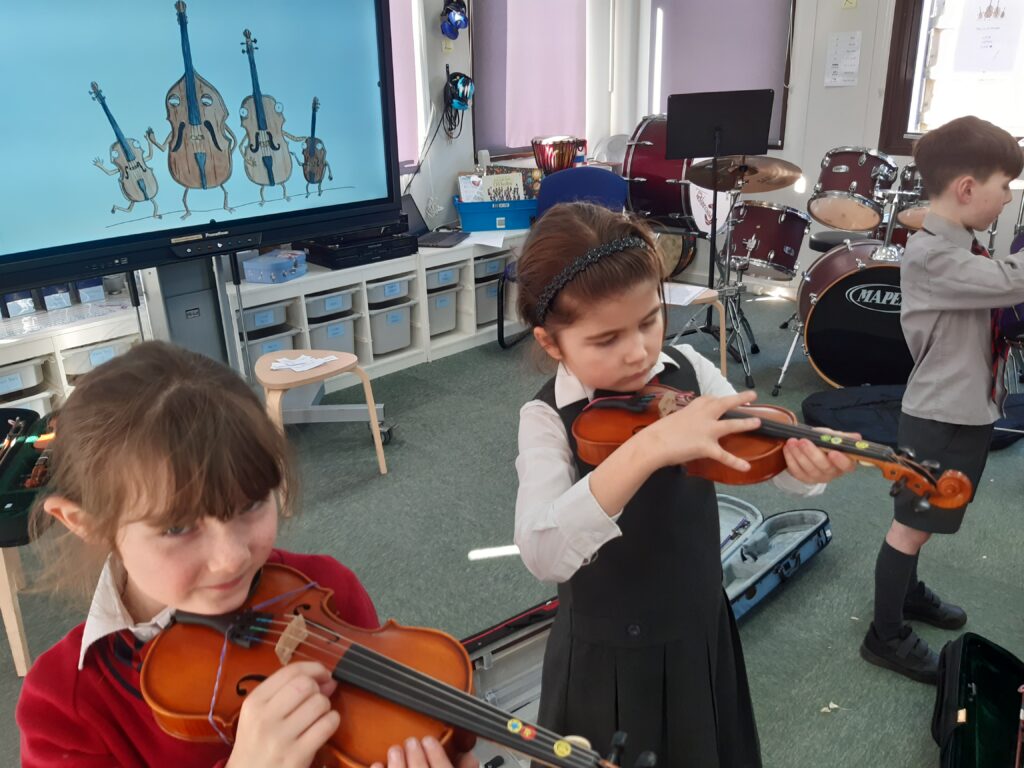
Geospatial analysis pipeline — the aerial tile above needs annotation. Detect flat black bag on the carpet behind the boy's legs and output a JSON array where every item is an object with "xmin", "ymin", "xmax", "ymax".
[{"xmin": 803, "ymin": 384, "xmax": 1024, "ymax": 451}]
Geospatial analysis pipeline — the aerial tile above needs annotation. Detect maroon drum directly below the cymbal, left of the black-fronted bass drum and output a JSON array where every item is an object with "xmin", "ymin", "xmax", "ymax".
[{"xmin": 729, "ymin": 201, "xmax": 811, "ymax": 280}]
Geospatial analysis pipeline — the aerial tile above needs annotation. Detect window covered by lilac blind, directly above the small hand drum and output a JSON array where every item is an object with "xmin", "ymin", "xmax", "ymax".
[{"xmin": 472, "ymin": 0, "xmax": 587, "ymax": 156}]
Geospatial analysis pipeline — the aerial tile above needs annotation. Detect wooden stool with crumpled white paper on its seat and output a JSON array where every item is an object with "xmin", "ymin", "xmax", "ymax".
[{"xmin": 254, "ymin": 349, "xmax": 387, "ymax": 475}]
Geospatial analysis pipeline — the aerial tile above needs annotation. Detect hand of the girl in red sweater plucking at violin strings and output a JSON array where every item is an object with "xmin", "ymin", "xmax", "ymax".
[{"xmin": 226, "ymin": 662, "xmax": 341, "ymax": 768}]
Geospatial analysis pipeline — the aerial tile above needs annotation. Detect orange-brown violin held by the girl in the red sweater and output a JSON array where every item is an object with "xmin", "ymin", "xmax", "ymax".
[{"xmin": 140, "ymin": 563, "xmax": 626, "ymax": 768}]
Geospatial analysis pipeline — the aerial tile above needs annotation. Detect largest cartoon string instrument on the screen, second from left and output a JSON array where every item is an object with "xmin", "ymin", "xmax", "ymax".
[{"xmin": 146, "ymin": 0, "xmax": 238, "ymax": 219}]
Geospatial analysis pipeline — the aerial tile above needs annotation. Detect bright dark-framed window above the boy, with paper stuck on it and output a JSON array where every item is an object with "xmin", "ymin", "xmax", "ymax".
[{"xmin": 881, "ymin": 0, "xmax": 1024, "ymax": 155}]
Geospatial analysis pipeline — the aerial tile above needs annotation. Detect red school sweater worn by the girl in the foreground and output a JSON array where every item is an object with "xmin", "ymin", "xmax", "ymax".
[{"xmin": 15, "ymin": 550, "xmax": 380, "ymax": 768}]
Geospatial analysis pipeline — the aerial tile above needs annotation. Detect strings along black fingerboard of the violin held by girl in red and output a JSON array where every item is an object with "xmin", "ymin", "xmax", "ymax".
[{"xmin": 241, "ymin": 621, "xmax": 600, "ymax": 768}]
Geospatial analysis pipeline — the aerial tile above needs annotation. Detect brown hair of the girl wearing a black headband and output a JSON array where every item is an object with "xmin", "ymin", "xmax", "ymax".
[{"xmin": 516, "ymin": 203, "xmax": 663, "ymax": 330}]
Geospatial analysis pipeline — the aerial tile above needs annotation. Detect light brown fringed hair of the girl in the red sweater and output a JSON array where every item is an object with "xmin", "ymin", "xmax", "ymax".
[{"xmin": 30, "ymin": 341, "xmax": 295, "ymax": 602}]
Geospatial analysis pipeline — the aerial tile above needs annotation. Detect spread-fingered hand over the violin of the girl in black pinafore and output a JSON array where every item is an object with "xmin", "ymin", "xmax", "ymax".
[{"xmin": 639, "ymin": 392, "xmax": 761, "ymax": 472}]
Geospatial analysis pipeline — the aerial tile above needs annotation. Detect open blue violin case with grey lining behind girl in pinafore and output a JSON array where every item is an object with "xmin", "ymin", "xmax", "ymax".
[{"xmin": 462, "ymin": 495, "xmax": 831, "ymax": 768}]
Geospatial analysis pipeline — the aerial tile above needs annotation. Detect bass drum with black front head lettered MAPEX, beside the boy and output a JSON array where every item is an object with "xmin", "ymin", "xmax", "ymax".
[{"xmin": 797, "ymin": 240, "xmax": 913, "ymax": 387}]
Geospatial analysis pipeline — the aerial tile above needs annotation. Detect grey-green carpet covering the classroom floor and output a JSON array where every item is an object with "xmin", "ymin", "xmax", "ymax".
[{"xmin": 0, "ymin": 301, "xmax": 1024, "ymax": 768}]
